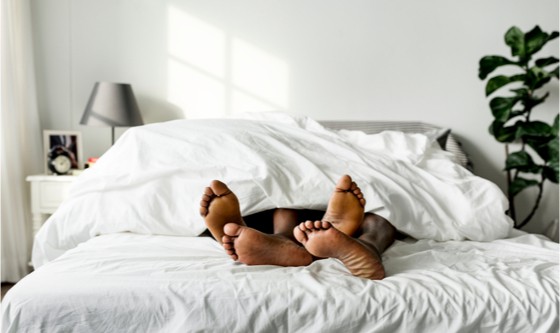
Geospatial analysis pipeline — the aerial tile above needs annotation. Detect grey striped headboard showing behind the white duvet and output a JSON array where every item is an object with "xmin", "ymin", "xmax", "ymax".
[{"xmin": 319, "ymin": 120, "xmax": 473, "ymax": 171}]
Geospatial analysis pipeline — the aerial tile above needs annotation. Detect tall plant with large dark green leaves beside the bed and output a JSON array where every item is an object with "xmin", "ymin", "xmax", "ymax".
[{"xmin": 478, "ymin": 26, "xmax": 559, "ymax": 228}]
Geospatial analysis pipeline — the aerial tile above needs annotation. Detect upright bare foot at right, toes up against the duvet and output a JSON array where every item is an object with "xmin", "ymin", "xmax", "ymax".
[{"xmin": 322, "ymin": 175, "xmax": 366, "ymax": 236}]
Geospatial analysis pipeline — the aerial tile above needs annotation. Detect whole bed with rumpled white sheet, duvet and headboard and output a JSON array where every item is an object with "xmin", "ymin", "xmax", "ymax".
[{"xmin": 2, "ymin": 113, "xmax": 559, "ymax": 332}]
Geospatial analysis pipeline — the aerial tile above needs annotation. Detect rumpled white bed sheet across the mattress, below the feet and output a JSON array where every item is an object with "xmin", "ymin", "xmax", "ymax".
[{"xmin": 2, "ymin": 233, "xmax": 559, "ymax": 333}]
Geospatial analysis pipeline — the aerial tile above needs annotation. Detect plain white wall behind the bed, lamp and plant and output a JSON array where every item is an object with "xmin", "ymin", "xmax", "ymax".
[{"xmin": 32, "ymin": 0, "xmax": 559, "ymax": 231}]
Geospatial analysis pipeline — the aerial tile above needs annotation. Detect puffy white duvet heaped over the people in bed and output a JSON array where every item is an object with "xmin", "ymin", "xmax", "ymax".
[{"xmin": 33, "ymin": 114, "xmax": 512, "ymax": 267}]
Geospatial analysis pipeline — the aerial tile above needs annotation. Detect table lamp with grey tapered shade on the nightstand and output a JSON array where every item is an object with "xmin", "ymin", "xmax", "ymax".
[{"xmin": 80, "ymin": 82, "xmax": 144, "ymax": 145}]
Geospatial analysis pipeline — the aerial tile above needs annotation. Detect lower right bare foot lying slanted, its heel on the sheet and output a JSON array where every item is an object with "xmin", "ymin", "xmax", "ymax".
[{"xmin": 294, "ymin": 221, "xmax": 385, "ymax": 280}]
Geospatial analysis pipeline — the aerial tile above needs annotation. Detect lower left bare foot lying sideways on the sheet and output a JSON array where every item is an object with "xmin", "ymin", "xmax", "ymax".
[{"xmin": 222, "ymin": 223, "xmax": 313, "ymax": 266}]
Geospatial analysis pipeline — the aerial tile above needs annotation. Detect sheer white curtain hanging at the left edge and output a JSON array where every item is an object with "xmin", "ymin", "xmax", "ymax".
[{"xmin": 0, "ymin": 0, "xmax": 43, "ymax": 282}]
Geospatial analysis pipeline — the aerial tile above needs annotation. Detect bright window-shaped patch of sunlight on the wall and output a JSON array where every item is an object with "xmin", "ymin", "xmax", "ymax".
[{"xmin": 167, "ymin": 6, "xmax": 289, "ymax": 118}]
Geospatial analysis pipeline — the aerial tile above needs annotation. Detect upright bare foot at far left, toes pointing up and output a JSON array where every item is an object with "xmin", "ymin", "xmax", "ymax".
[{"xmin": 200, "ymin": 180, "xmax": 245, "ymax": 243}]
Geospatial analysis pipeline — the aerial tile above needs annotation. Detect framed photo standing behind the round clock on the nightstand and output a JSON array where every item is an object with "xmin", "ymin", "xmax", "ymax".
[{"xmin": 43, "ymin": 130, "xmax": 82, "ymax": 175}]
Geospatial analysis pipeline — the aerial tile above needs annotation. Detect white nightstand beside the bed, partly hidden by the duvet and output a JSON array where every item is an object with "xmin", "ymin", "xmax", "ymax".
[{"xmin": 25, "ymin": 175, "xmax": 78, "ymax": 237}]
